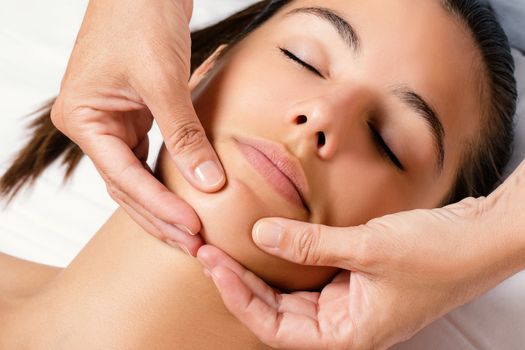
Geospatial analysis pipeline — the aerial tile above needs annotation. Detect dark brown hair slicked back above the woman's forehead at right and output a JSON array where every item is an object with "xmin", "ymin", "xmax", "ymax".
[{"xmin": 441, "ymin": 0, "xmax": 518, "ymax": 203}]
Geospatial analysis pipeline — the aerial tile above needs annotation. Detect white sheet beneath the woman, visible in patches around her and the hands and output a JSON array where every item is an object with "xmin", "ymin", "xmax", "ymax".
[{"xmin": 0, "ymin": 0, "xmax": 525, "ymax": 350}]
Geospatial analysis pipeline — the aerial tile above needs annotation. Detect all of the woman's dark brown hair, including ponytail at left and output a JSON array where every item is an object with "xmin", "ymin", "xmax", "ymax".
[{"xmin": 0, "ymin": 0, "xmax": 517, "ymax": 202}]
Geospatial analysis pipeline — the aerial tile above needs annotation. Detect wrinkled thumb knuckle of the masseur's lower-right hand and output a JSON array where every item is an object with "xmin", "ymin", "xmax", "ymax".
[{"xmin": 293, "ymin": 224, "xmax": 321, "ymax": 265}]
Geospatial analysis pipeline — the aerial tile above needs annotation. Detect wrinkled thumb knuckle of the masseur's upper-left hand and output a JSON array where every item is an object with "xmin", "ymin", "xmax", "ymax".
[{"xmin": 166, "ymin": 120, "xmax": 206, "ymax": 155}]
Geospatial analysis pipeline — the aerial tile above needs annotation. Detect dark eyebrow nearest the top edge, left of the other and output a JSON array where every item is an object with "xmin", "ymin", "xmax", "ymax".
[{"xmin": 285, "ymin": 7, "xmax": 361, "ymax": 51}]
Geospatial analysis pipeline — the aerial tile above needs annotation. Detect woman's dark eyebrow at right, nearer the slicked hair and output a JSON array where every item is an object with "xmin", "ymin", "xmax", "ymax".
[{"xmin": 393, "ymin": 86, "xmax": 445, "ymax": 172}]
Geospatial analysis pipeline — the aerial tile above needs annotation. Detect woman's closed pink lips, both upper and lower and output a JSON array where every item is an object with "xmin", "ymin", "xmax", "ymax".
[{"xmin": 234, "ymin": 137, "xmax": 309, "ymax": 210}]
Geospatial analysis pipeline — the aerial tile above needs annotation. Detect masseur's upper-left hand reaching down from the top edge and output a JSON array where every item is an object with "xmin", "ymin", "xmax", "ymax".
[{"xmin": 51, "ymin": 0, "xmax": 225, "ymax": 255}]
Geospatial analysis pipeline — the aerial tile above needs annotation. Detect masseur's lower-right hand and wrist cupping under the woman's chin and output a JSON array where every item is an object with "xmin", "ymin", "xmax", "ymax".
[{"xmin": 198, "ymin": 162, "xmax": 525, "ymax": 350}]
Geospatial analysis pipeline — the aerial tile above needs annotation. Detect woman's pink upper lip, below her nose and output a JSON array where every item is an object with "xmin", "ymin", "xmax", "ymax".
[{"xmin": 235, "ymin": 137, "xmax": 310, "ymax": 210}]
